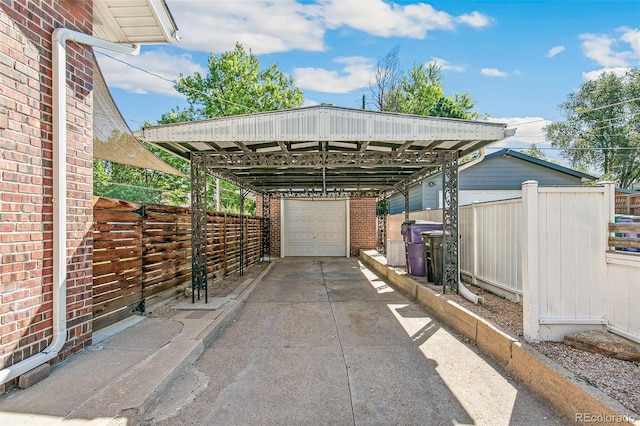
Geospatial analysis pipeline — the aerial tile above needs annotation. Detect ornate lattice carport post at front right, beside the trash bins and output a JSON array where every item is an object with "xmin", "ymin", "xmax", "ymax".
[{"xmin": 442, "ymin": 151, "xmax": 460, "ymax": 293}]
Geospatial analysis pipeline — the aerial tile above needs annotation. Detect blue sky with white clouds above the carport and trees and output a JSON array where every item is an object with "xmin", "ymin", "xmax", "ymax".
[{"xmin": 97, "ymin": 0, "xmax": 640, "ymax": 164}]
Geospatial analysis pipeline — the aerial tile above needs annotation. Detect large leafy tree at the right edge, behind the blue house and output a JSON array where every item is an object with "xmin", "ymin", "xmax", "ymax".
[{"xmin": 544, "ymin": 69, "xmax": 640, "ymax": 188}]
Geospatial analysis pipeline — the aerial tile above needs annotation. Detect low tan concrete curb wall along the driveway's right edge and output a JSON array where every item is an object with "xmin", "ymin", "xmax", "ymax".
[{"xmin": 360, "ymin": 250, "xmax": 640, "ymax": 424}]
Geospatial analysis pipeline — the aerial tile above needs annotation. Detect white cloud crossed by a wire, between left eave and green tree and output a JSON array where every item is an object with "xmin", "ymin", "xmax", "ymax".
[{"xmin": 96, "ymin": 50, "xmax": 207, "ymax": 97}]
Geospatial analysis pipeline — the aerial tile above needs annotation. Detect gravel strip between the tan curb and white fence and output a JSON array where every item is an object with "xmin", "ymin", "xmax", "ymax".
[{"xmin": 439, "ymin": 286, "xmax": 640, "ymax": 418}]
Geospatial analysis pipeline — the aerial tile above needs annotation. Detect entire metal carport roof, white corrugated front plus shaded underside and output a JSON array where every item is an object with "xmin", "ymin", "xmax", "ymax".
[{"xmin": 141, "ymin": 105, "xmax": 509, "ymax": 195}]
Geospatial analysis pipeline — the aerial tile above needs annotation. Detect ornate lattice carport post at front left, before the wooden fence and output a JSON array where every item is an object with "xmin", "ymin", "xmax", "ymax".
[{"xmin": 191, "ymin": 152, "xmax": 208, "ymax": 303}]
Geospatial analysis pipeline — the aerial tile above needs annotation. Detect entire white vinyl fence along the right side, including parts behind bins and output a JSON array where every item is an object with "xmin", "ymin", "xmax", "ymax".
[{"xmin": 388, "ymin": 181, "xmax": 640, "ymax": 343}]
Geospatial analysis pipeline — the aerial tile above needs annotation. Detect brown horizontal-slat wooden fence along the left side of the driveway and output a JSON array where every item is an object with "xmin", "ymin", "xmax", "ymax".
[{"xmin": 93, "ymin": 197, "xmax": 261, "ymax": 330}]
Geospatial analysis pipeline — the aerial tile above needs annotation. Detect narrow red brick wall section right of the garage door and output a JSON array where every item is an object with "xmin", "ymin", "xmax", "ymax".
[{"xmin": 349, "ymin": 198, "xmax": 376, "ymax": 256}]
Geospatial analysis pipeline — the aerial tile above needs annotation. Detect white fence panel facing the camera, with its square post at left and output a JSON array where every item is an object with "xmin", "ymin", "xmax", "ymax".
[{"xmin": 523, "ymin": 181, "xmax": 613, "ymax": 341}]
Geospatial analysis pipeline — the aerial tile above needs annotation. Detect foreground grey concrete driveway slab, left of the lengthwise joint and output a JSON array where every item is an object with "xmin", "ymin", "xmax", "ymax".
[{"xmin": 149, "ymin": 346, "xmax": 354, "ymax": 426}]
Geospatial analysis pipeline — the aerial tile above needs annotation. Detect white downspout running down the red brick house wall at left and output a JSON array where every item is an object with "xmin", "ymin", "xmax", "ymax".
[{"xmin": 0, "ymin": 28, "xmax": 140, "ymax": 385}]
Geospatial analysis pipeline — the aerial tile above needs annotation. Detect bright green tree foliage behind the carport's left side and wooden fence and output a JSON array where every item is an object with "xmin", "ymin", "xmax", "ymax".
[{"xmin": 101, "ymin": 44, "xmax": 303, "ymax": 214}]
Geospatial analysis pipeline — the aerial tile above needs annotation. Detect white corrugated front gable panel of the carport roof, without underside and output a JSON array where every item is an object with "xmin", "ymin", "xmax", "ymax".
[{"xmin": 144, "ymin": 106, "xmax": 506, "ymax": 145}]
